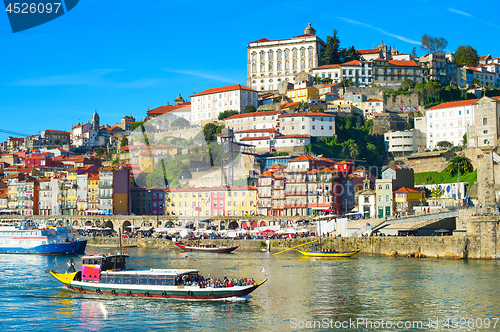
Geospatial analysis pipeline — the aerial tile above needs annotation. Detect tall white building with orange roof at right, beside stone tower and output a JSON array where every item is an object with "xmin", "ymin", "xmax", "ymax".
[{"xmin": 425, "ymin": 99, "xmax": 478, "ymax": 149}]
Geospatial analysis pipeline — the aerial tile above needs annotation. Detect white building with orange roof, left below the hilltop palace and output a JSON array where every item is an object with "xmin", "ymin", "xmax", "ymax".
[{"xmin": 191, "ymin": 84, "xmax": 258, "ymax": 125}]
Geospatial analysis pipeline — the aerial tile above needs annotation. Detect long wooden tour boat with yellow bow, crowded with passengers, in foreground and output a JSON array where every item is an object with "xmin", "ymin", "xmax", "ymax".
[{"xmin": 46, "ymin": 253, "xmax": 267, "ymax": 300}]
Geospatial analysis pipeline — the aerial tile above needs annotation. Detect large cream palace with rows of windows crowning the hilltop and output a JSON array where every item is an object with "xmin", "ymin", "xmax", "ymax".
[{"xmin": 247, "ymin": 23, "xmax": 325, "ymax": 91}]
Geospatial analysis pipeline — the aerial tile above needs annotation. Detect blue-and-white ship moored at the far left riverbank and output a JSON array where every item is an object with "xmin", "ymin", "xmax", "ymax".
[{"xmin": 0, "ymin": 220, "xmax": 87, "ymax": 255}]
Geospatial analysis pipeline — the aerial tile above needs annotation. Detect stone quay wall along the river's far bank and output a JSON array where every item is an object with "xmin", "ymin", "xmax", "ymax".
[{"xmin": 83, "ymin": 210, "xmax": 500, "ymax": 259}]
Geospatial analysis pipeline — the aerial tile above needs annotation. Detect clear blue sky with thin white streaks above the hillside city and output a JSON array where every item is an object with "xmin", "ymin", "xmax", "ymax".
[{"xmin": 0, "ymin": 0, "xmax": 500, "ymax": 141}]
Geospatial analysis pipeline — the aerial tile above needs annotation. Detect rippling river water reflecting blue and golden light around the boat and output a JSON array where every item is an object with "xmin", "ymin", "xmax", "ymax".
[{"xmin": 0, "ymin": 247, "xmax": 500, "ymax": 331}]
